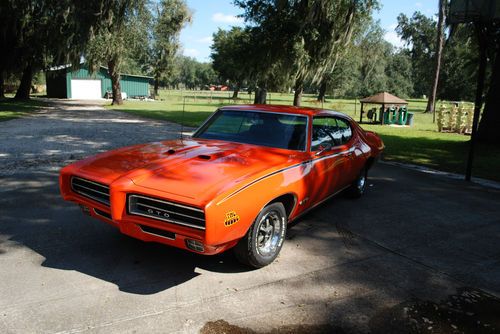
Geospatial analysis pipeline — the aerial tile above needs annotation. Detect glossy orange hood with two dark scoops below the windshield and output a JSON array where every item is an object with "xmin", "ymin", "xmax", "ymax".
[{"xmin": 76, "ymin": 139, "xmax": 303, "ymax": 200}]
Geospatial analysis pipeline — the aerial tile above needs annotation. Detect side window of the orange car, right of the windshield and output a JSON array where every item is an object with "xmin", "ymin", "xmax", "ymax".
[{"xmin": 311, "ymin": 117, "xmax": 352, "ymax": 151}]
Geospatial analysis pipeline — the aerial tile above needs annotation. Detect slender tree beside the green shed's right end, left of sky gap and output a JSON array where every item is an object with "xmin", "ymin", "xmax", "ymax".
[{"xmin": 151, "ymin": 0, "xmax": 191, "ymax": 95}]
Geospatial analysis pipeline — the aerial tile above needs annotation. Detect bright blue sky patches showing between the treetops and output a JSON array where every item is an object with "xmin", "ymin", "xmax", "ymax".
[{"xmin": 180, "ymin": 0, "xmax": 438, "ymax": 62}]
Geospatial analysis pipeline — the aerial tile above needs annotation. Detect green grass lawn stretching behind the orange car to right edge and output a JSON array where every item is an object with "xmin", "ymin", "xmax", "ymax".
[{"xmin": 107, "ymin": 91, "xmax": 500, "ymax": 181}]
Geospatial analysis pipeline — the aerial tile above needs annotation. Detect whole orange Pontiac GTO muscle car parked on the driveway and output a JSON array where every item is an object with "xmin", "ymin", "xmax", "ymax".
[{"xmin": 60, "ymin": 105, "xmax": 384, "ymax": 267}]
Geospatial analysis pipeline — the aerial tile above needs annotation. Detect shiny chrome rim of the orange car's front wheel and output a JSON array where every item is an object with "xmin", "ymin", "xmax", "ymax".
[{"xmin": 255, "ymin": 211, "xmax": 283, "ymax": 256}]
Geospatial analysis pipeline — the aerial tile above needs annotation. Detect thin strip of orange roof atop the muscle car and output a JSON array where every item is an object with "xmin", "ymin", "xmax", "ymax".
[{"xmin": 219, "ymin": 104, "xmax": 350, "ymax": 118}]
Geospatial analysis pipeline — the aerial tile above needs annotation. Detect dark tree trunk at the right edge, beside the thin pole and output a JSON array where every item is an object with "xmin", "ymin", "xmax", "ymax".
[{"xmin": 477, "ymin": 39, "xmax": 500, "ymax": 144}]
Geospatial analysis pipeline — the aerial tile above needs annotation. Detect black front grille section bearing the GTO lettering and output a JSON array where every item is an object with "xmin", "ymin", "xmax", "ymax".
[{"xmin": 128, "ymin": 195, "xmax": 205, "ymax": 230}]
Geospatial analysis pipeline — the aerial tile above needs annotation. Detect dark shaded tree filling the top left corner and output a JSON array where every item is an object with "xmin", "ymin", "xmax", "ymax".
[{"xmin": 0, "ymin": 0, "xmax": 105, "ymax": 99}]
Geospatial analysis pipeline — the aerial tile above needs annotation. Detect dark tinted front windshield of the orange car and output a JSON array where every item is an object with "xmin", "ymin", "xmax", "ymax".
[{"xmin": 193, "ymin": 110, "xmax": 307, "ymax": 151}]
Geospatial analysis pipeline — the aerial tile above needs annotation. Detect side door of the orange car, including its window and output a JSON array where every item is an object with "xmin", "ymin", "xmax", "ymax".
[{"xmin": 308, "ymin": 116, "xmax": 353, "ymax": 205}]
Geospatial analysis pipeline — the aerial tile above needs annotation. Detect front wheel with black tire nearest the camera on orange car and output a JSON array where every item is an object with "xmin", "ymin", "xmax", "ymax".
[{"xmin": 234, "ymin": 203, "xmax": 287, "ymax": 268}]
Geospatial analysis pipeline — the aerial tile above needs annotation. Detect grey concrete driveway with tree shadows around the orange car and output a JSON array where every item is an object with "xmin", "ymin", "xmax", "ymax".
[{"xmin": 0, "ymin": 102, "xmax": 500, "ymax": 333}]
